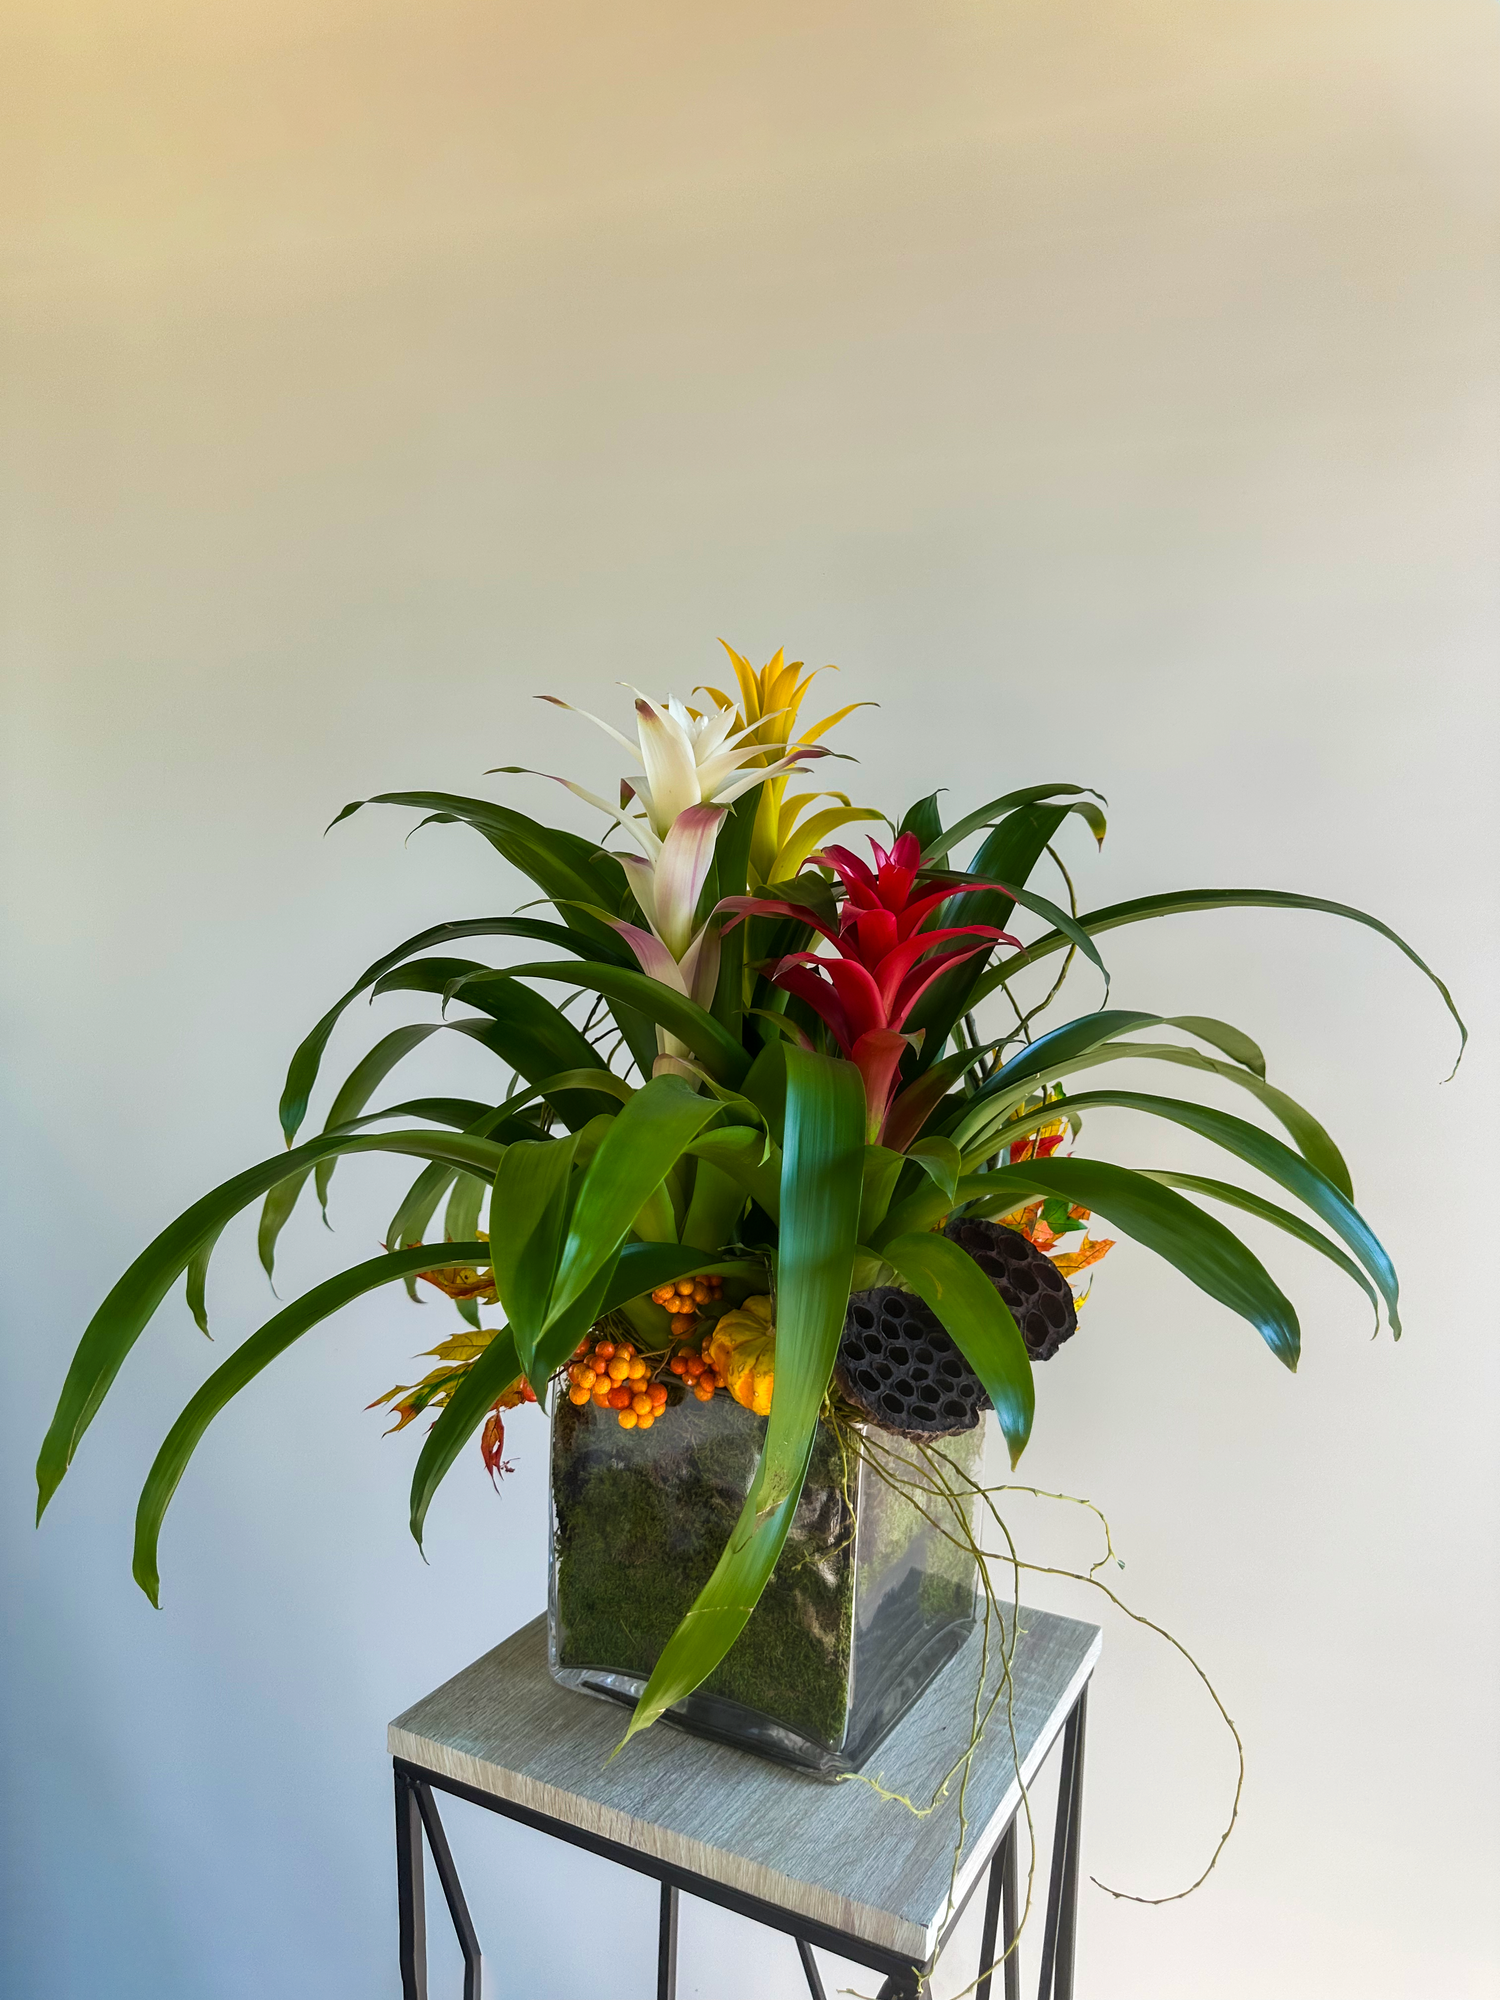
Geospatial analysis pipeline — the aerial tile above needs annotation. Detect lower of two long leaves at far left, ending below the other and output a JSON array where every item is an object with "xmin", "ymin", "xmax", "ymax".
[{"xmin": 134, "ymin": 1242, "xmax": 490, "ymax": 1608}]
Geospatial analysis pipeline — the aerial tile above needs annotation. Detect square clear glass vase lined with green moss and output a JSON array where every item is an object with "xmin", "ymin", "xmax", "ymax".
[{"xmin": 548, "ymin": 1394, "xmax": 984, "ymax": 1778}]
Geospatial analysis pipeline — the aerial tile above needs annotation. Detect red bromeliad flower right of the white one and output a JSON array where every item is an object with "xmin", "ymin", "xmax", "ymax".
[{"xmin": 720, "ymin": 834, "xmax": 1020, "ymax": 1142}]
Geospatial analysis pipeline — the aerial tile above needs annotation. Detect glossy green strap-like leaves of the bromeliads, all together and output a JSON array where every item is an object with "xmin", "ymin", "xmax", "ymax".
[{"xmin": 38, "ymin": 736, "xmax": 1462, "ymax": 1732}]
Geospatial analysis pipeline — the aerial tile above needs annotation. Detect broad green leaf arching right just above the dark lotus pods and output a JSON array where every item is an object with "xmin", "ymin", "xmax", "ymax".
[{"xmin": 960, "ymin": 1160, "xmax": 1302, "ymax": 1368}]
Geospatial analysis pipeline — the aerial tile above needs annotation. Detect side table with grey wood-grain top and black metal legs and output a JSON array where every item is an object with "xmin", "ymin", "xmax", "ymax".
[{"xmin": 388, "ymin": 1606, "xmax": 1100, "ymax": 2000}]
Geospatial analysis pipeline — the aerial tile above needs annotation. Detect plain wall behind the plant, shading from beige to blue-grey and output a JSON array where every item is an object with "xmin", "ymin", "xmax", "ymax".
[{"xmin": 0, "ymin": 0, "xmax": 1500, "ymax": 2000}]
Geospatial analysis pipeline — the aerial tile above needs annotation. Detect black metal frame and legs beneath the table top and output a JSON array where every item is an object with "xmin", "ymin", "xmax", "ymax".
[{"xmin": 392, "ymin": 1684, "xmax": 1088, "ymax": 2000}]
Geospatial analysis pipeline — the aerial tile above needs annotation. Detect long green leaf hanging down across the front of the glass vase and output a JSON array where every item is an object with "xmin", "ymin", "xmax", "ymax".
[{"xmin": 624, "ymin": 1048, "xmax": 866, "ymax": 1742}]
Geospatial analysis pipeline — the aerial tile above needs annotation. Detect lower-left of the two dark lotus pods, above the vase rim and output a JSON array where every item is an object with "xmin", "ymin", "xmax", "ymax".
[{"xmin": 834, "ymin": 1284, "xmax": 990, "ymax": 1438}]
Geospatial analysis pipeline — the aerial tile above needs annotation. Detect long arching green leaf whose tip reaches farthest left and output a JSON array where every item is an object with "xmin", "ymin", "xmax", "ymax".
[{"xmin": 36, "ymin": 1132, "xmax": 516, "ymax": 1520}]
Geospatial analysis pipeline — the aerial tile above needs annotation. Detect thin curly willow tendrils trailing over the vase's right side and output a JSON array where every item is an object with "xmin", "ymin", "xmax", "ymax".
[{"xmin": 824, "ymin": 1410, "xmax": 1244, "ymax": 2000}]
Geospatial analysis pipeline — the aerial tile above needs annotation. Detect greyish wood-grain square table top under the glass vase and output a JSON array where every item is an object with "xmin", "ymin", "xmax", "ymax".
[{"xmin": 388, "ymin": 1606, "xmax": 1102, "ymax": 1962}]
